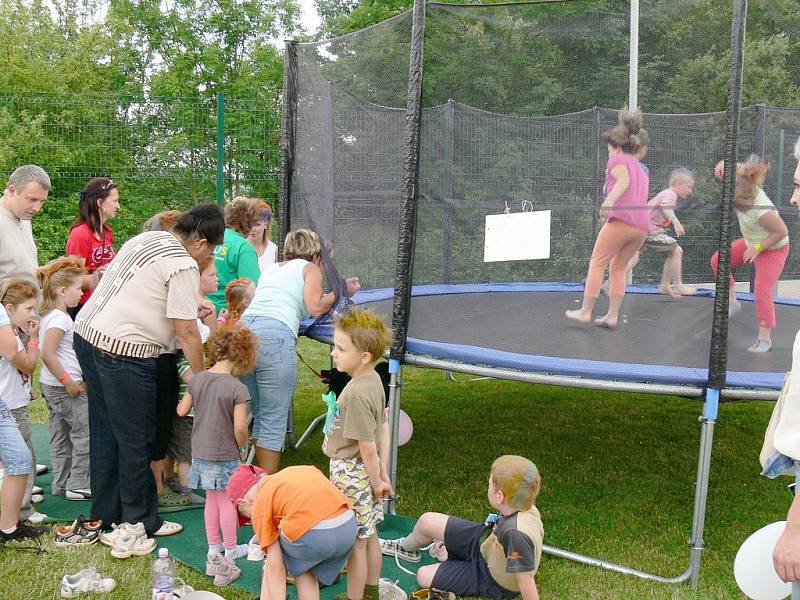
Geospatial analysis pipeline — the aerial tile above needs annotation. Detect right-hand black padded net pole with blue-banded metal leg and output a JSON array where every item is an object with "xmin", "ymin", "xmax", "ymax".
[{"xmin": 689, "ymin": 0, "xmax": 747, "ymax": 589}]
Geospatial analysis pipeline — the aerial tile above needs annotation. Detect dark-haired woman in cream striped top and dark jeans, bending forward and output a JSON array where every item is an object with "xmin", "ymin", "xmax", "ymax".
[{"xmin": 74, "ymin": 204, "xmax": 225, "ymax": 540}]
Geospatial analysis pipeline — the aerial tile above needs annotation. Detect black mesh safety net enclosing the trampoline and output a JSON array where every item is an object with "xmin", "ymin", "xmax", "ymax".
[{"xmin": 289, "ymin": 0, "xmax": 800, "ymax": 388}]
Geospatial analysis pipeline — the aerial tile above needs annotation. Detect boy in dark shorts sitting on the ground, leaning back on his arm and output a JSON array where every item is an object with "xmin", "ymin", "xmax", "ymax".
[{"xmin": 381, "ymin": 455, "xmax": 544, "ymax": 600}]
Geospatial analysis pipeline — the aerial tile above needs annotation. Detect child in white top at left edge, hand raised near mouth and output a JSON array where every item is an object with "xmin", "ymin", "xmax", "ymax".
[{"xmin": 0, "ymin": 279, "xmax": 42, "ymax": 522}]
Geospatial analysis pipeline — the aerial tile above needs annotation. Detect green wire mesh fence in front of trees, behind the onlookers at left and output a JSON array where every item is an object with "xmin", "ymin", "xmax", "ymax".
[{"xmin": 0, "ymin": 92, "xmax": 281, "ymax": 262}]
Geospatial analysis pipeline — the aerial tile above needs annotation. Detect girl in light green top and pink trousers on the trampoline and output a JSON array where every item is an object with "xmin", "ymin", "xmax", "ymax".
[{"xmin": 711, "ymin": 155, "xmax": 789, "ymax": 353}]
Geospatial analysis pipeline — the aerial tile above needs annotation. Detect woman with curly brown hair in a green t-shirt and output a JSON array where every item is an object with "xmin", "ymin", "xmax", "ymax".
[{"xmin": 208, "ymin": 196, "xmax": 261, "ymax": 314}]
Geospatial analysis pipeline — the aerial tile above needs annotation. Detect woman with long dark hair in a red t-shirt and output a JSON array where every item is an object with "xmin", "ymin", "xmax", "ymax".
[{"xmin": 67, "ymin": 177, "xmax": 119, "ymax": 319}]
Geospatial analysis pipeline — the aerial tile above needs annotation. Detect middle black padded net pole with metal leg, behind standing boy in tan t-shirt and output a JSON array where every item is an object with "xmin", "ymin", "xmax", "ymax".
[{"xmin": 389, "ymin": 0, "xmax": 425, "ymax": 512}]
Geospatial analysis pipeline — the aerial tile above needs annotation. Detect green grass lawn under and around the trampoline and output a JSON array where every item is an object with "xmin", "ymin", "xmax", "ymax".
[{"xmin": 0, "ymin": 340, "xmax": 790, "ymax": 600}]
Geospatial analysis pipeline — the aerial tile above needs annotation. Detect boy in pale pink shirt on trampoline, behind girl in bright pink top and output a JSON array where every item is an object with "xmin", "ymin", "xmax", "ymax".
[{"xmin": 643, "ymin": 168, "xmax": 695, "ymax": 298}]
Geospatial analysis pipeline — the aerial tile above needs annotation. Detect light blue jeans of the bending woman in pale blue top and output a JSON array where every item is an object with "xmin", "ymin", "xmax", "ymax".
[{"xmin": 240, "ymin": 317, "xmax": 297, "ymax": 452}]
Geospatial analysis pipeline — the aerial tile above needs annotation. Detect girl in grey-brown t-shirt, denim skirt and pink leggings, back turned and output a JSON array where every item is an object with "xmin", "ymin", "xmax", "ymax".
[{"xmin": 177, "ymin": 325, "xmax": 256, "ymax": 585}]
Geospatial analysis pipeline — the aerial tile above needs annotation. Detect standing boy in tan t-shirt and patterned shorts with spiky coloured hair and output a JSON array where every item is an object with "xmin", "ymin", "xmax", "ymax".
[{"xmin": 322, "ymin": 309, "xmax": 393, "ymax": 600}]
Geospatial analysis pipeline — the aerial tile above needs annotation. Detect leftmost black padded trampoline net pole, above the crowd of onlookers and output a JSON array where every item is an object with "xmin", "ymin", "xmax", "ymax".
[{"xmin": 278, "ymin": 40, "xmax": 297, "ymax": 258}]
